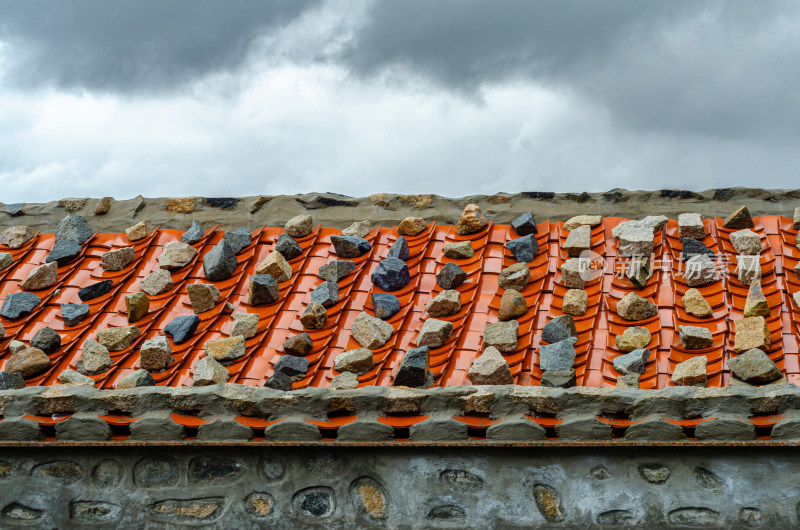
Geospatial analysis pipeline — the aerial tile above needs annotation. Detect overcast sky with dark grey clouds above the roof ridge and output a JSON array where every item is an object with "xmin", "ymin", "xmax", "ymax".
[{"xmin": 0, "ymin": 0, "xmax": 800, "ymax": 202}]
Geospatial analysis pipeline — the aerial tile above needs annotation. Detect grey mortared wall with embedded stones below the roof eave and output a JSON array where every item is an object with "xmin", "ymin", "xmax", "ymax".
[{"xmin": 0, "ymin": 446, "xmax": 800, "ymax": 529}]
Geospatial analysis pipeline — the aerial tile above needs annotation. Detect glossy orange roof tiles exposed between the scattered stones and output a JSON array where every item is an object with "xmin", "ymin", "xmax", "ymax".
[{"xmin": 0, "ymin": 212, "xmax": 800, "ymax": 390}]
